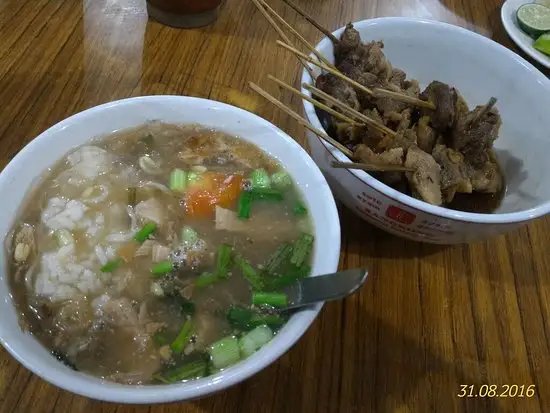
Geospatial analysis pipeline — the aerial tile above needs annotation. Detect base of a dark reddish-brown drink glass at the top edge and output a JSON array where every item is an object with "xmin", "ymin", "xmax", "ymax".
[{"xmin": 147, "ymin": 0, "xmax": 223, "ymax": 29}]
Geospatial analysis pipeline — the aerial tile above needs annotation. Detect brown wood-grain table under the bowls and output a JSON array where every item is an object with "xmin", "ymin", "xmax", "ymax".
[{"xmin": 0, "ymin": 0, "xmax": 550, "ymax": 413}]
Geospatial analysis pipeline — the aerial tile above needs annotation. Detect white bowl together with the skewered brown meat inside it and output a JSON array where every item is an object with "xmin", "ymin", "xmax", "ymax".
[{"xmin": 302, "ymin": 17, "xmax": 550, "ymax": 244}]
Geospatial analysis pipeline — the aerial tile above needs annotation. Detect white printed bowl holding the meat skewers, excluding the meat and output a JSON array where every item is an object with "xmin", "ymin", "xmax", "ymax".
[{"xmin": 302, "ymin": 17, "xmax": 550, "ymax": 244}]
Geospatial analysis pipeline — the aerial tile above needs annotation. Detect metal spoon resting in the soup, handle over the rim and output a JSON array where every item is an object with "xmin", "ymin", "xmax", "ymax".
[{"xmin": 282, "ymin": 268, "xmax": 368, "ymax": 310}]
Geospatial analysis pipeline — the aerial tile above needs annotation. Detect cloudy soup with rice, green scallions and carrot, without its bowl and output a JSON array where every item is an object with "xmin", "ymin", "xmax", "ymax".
[{"xmin": 5, "ymin": 122, "xmax": 314, "ymax": 384}]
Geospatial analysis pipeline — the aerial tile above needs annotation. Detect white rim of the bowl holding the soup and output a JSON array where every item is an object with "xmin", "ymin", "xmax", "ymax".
[{"xmin": 0, "ymin": 95, "xmax": 341, "ymax": 404}]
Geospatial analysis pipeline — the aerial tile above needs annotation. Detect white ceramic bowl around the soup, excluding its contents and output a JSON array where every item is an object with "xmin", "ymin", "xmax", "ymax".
[{"xmin": 0, "ymin": 96, "xmax": 340, "ymax": 403}]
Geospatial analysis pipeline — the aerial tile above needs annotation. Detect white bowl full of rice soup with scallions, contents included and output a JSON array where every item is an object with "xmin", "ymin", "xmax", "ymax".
[{"xmin": 0, "ymin": 96, "xmax": 340, "ymax": 403}]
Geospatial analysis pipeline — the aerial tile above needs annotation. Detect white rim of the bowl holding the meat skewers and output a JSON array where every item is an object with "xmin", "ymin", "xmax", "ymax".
[{"xmin": 301, "ymin": 17, "xmax": 550, "ymax": 225}]
